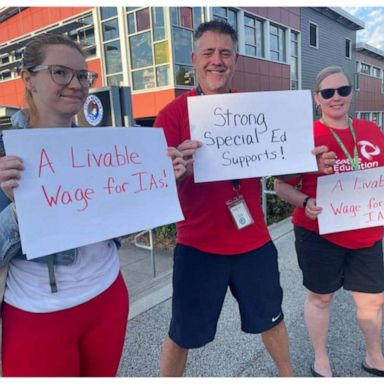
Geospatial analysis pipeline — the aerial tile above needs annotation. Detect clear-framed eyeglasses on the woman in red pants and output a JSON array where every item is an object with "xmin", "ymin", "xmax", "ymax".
[{"xmin": 29, "ymin": 65, "xmax": 98, "ymax": 88}]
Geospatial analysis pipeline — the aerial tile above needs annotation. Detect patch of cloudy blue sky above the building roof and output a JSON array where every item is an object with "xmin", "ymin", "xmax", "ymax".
[{"xmin": 343, "ymin": 7, "xmax": 384, "ymax": 51}]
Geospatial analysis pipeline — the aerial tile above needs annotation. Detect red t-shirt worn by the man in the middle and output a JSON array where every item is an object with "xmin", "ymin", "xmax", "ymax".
[{"xmin": 154, "ymin": 89, "xmax": 270, "ymax": 255}]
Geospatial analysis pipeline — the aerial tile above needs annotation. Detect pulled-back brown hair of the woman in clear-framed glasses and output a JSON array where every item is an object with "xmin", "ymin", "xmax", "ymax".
[{"xmin": 21, "ymin": 33, "xmax": 85, "ymax": 126}]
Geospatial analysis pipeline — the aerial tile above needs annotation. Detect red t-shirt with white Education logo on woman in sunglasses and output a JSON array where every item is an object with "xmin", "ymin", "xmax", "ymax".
[{"xmin": 290, "ymin": 119, "xmax": 384, "ymax": 249}]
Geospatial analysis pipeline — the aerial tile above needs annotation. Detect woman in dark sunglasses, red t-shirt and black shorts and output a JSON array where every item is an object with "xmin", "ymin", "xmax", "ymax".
[{"xmin": 275, "ymin": 67, "xmax": 384, "ymax": 376}]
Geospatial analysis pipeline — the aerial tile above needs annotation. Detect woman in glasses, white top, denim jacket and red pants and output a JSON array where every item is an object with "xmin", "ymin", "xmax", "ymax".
[{"xmin": 0, "ymin": 34, "xmax": 185, "ymax": 377}]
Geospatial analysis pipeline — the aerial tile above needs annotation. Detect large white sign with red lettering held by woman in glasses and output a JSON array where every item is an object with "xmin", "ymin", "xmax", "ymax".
[{"xmin": 4, "ymin": 128, "xmax": 183, "ymax": 259}]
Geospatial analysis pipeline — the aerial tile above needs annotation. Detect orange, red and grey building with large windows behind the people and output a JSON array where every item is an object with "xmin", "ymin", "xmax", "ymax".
[{"xmin": 0, "ymin": 6, "xmax": 376, "ymax": 125}]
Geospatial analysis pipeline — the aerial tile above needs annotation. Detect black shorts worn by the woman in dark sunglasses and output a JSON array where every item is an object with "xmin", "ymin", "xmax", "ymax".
[{"xmin": 294, "ymin": 226, "xmax": 384, "ymax": 294}]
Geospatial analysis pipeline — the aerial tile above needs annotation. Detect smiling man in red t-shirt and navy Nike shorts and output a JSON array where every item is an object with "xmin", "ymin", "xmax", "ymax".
[{"xmin": 154, "ymin": 20, "xmax": 332, "ymax": 376}]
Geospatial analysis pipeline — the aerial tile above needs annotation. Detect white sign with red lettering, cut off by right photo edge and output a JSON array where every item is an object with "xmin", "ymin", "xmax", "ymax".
[{"xmin": 316, "ymin": 167, "xmax": 384, "ymax": 234}]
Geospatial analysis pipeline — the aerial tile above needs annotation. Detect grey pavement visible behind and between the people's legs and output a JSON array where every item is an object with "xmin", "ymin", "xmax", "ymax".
[{"xmin": 119, "ymin": 220, "xmax": 380, "ymax": 377}]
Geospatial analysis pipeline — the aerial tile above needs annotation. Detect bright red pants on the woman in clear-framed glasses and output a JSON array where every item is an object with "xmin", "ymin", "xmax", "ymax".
[{"xmin": 2, "ymin": 274, "xmax": 129, "ymax": 377}]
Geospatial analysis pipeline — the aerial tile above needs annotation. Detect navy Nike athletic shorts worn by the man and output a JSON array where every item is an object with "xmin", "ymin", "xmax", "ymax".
[{"xmin": 169, "ymin": 242, "xmax": 283, "ymax": 348}]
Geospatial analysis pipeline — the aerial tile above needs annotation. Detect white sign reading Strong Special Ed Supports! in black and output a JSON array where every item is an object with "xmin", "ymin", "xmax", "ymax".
[{"xmin": 188, "ymin": 91, "xmax": 317, "ymax": 182}]
